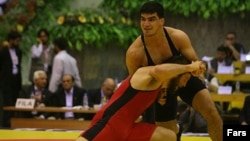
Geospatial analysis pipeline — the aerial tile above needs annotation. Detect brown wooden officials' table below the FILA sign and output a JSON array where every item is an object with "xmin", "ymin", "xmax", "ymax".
[{"xmin": 3, "ymin": 106, "xmax": 97, "ymax": 130}]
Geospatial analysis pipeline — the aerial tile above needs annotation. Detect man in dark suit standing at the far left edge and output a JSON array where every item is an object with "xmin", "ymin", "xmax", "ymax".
[{"xmin": 0, "ymin": 31, "xmax": 22, "ymax": 127}]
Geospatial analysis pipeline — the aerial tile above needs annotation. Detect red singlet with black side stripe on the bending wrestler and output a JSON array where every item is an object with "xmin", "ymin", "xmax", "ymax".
[{"xmin": 81, "ymin": 77, "xmax": 160, "ymax": 141}]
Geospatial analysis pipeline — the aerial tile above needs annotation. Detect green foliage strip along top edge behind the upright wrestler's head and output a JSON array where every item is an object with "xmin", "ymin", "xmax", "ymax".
[{"xmin": 102, "ymin": 0, "xmax": 250, "ymax": 19}]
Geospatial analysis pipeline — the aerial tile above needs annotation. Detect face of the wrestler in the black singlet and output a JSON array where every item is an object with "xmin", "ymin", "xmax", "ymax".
[{"xmin": 140, "ymin": 12, "xmax": 164, "ymax": 36}]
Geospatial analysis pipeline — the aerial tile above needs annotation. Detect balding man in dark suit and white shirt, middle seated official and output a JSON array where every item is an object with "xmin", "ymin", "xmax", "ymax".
[{"xmin": 55, "ymin": 74, "xmax": 86, "ymax": 119}]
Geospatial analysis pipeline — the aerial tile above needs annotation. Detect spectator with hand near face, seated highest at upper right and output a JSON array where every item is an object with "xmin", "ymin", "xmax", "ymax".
[{"xmin": 220, "ymin": 31, "xmax": 246, "ymax": 61}]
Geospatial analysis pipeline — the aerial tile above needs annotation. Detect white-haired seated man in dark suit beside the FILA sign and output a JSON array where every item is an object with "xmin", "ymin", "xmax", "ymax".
[{"xmin": 19, "ymin": 70, "xmax": 53, "ymax": 118}]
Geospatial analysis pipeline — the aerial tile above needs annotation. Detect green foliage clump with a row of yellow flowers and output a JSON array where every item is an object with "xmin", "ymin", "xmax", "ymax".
[{"xmin": 53, "ymin": 9, "xmax": 138, "ymax": 50}]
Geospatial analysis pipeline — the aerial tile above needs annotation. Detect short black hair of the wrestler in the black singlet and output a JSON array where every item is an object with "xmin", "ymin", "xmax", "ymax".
[{"xmin": 140, "ymin": 1, "xmax": 164, "ymax": 18}]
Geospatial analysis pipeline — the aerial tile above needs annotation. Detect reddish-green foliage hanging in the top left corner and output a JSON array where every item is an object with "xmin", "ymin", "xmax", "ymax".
[{"xmin": 0, "ymin": 0, "xmax": 71, "ymax": 53}]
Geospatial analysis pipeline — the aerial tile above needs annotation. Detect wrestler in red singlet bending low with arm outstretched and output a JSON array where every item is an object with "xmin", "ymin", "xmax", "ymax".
[{"xmin": 76, "ymin": 56, "xmax": 205, "ymax": 141}]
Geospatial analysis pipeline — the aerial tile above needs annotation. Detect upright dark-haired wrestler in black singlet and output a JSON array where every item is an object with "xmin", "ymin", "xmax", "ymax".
[{"xmin": 126, "ymin": 1, "xmax": 222, "ymax": 141}]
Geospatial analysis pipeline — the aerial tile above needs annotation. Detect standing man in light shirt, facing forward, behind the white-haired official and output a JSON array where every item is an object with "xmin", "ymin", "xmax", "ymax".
[{"xmin": 30, "ymin": 28, "xmax": 54, "ymax": 87}]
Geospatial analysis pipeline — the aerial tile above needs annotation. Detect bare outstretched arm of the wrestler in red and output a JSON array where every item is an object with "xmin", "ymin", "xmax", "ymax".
[{"xmin": 133, "ymin": 61, "xmax": 205, "ymax": 89}]
